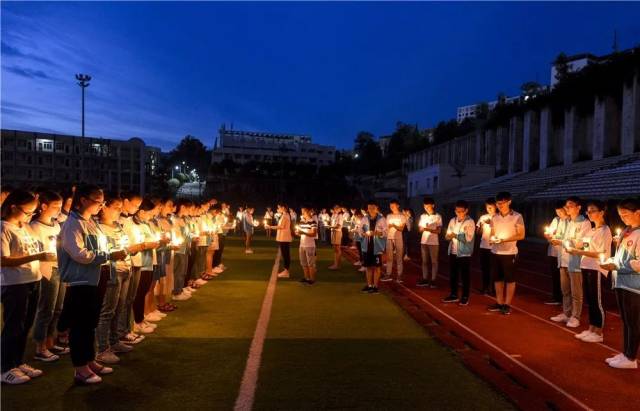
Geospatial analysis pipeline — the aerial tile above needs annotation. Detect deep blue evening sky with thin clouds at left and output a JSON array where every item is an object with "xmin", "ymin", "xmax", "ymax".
[{"xmin": 1, "ymin": 2, "xmax": 640, "ymax": 150}]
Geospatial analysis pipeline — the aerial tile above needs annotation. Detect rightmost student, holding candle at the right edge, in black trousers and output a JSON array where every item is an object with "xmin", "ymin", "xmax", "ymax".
[{"xmin": 600, "ymin": 198, "xmax": 640, "ymax": 369}]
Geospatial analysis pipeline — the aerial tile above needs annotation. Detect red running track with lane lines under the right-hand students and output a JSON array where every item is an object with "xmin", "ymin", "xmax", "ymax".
[{"xmin": 345, "ymin": 243, "xmax": 640, "ymax": 410}]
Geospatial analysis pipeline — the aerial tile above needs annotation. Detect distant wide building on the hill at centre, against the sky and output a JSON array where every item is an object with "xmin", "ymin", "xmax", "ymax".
[{"xmin": 211, "ymin": 125, "xmax": 336, "ymax": 166}]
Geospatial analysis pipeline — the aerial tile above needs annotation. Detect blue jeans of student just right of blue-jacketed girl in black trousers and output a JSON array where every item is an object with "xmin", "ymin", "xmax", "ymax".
[{"xmin": 96, "ymin": 271, "xmax": 131, "ymax": 352}]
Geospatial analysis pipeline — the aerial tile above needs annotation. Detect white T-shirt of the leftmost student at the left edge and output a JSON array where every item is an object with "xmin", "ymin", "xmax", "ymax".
[{"xmin": 0, "ymin": 221, "xmax": 42, "ymax": 285}]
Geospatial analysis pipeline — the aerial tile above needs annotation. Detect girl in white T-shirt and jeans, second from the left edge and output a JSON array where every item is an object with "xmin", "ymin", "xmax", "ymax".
[{"xmin": 30, "ymin": 191, "xmax": 69, "ymax": 362}]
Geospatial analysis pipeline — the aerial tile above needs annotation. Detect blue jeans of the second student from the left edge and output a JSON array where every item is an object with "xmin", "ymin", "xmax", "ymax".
[{"xmin": 33, "ymin": 268, "xmax": 66, "ymax": 343}]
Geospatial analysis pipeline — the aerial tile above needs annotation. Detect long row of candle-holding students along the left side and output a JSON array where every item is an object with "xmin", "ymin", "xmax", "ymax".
[{"xmin": 0, "ymin": 185, "xmax": 232, "ymax": 384}]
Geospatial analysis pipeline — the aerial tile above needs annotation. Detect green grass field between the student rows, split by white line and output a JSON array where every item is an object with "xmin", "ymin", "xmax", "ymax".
[{"xmin": 2, "ymin": 238, "xmax": 513, "ymax": 410}]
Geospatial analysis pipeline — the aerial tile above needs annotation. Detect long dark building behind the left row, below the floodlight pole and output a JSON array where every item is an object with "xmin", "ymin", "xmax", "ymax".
[{"xmin": 2, "ymin": 129, "xmax": 160, "ymax": 195}]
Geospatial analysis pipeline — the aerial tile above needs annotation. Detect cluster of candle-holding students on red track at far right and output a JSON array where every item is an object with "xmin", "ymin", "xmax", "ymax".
[{"xmin": 545, "ymin": 197, "xmax": 640, "ymax": 368}]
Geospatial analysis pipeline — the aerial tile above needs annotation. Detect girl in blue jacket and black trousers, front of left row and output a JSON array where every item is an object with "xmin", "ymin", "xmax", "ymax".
[{"xmin": 58, "ymin": 185, "xmax": 127, "ymax": 384}]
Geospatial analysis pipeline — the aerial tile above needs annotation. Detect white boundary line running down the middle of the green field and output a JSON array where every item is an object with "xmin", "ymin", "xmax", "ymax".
[{"xmin": 233, "ymin": 258, "xmax": 278, "ymax": 411}]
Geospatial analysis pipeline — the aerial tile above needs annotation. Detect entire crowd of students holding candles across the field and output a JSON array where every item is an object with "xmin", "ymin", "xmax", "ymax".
[{"xmin": 0, "ymin": 185, "xmax": 640, "ymax": 384}]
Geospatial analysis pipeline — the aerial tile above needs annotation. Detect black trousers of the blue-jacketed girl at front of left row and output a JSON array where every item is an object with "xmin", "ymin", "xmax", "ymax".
[{"xmin": 65, "ymin": 285, "xmax": 102, "ymax": 367}]
